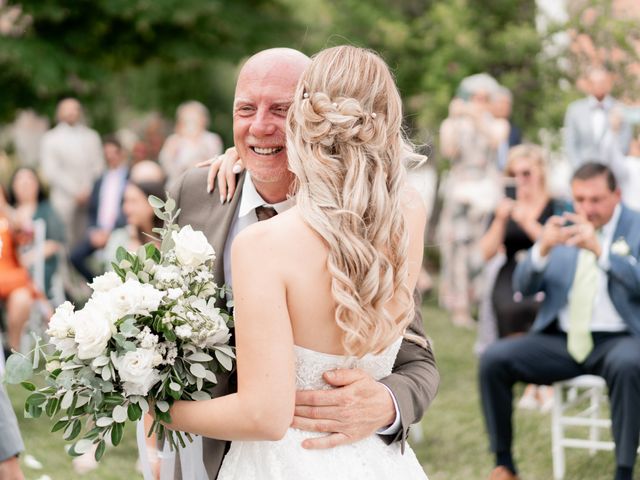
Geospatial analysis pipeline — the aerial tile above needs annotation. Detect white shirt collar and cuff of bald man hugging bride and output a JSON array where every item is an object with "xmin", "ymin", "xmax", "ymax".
[{"xmin": 223, "ymin": 172, "xmax": 401, "ymax": 435}]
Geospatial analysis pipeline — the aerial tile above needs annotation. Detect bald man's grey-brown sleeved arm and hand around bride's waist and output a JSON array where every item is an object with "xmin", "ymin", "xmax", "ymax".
[{"xmin": 292, "ymin": 288, "xmax": 440, "ymax": 448}]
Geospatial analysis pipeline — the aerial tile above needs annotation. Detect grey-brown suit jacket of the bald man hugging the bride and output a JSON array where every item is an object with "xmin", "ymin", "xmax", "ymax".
[{"xmin": 171, "ymin": 168, "xmax": 440, "ymax": 479}]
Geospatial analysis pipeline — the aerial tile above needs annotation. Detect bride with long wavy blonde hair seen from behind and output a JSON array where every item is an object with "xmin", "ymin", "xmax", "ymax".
[{"xmin": 168, "ymin": 46, "xmax": 426, "ymax": 480}]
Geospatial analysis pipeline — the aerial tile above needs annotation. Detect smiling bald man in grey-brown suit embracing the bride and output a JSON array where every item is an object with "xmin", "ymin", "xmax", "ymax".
[{"xmin": 171, "ymin": 49, "xmax": 439, "ymax": 479}]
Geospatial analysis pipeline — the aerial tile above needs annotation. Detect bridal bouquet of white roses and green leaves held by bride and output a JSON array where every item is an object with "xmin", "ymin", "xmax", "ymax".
[{"xmin": 6, "ymin": 197, "xmax": 234, "ymax": 460}]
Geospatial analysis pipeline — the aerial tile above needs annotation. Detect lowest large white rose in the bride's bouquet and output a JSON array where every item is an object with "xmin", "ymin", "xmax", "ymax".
[{"xmin": 114, "ymin": 348, "xmax": 160, "ymax": 396}]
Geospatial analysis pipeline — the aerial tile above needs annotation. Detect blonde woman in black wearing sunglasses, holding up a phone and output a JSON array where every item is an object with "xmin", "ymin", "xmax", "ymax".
[{"xmin": 476, "ymin": 144, "xmax": 563, "ymax": 411}]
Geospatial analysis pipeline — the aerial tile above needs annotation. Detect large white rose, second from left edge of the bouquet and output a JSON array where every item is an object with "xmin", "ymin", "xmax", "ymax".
[{"xmin": 73, "ymin": 300, "xmax": 115, "ymax": 360}]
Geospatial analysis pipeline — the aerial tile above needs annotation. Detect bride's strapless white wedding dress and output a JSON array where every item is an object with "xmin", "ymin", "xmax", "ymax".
[{"xmin": 218, "ymin": 339, "xmax": 427, "ymax": 480}]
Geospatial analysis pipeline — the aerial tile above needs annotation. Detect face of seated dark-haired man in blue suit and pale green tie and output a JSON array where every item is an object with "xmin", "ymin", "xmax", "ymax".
[{"xmin": 571, "ymin": 175, "xmax": 620, "ymax": 228}]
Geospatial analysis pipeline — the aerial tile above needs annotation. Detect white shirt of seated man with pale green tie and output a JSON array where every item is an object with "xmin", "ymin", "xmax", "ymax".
[{"xmin": 531, "ymin": 205, "xmax": 627, "ymax": 332}]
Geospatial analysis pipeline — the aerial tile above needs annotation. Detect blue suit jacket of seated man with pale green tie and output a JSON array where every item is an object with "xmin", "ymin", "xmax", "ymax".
[{"xmin": 513, "ymin": 206, "xmax": 640, "ymax": 336}]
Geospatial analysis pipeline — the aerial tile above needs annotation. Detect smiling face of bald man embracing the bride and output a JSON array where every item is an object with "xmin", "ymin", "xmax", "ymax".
[{"xmin": 233, "ymin": 58, "xmax": 302, "ymax": 200}]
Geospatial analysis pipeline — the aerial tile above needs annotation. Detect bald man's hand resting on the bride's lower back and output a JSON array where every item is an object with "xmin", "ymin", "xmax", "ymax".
[{"xmin": 291, "ymin": 369, "xmax": 396, "ymax": 449}]
